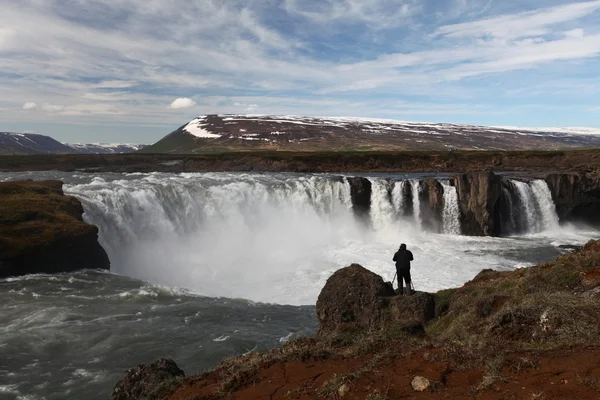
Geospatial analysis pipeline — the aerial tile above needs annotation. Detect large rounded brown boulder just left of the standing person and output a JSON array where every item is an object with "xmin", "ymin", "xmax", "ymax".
[{"xmin": 317, "ymin": 264, "xmax": 395, "ymax": 336}]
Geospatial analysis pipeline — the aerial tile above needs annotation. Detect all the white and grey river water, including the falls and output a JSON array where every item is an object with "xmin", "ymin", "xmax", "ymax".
[{"xmin": 0, "ymin": 172, "xmax": 598, "ymax": 399}]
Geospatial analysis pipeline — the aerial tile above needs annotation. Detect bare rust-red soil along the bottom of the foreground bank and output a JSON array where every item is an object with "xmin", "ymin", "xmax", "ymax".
[{"xmin": 168, "ymin": 343, "xmax": 600, "ymax": 400}]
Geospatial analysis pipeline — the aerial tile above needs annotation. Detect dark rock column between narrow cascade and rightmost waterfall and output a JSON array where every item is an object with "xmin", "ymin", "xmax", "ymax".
[{"xmin": 451, "ymin": 172, "xmax": 502, "ymax": 236}]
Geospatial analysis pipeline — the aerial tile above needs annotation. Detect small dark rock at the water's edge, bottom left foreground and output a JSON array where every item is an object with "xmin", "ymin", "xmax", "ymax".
[{"xmin": 112, "ymin": 358, "xmax": 185, "ymax": 400}]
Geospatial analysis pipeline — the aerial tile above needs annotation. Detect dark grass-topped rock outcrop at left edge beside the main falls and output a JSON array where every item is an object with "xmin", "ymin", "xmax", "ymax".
[{"xmin": 0, "ymin": 181, "xmax": 110, "ymax": 278}]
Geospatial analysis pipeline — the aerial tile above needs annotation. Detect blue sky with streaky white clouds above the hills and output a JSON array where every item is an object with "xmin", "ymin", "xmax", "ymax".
[{"xmin": 0, "ymin": 0, "xmax": 600, "ymax": 143}]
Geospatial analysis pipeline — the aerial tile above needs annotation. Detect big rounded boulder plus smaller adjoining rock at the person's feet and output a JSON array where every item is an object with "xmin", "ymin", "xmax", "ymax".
[{"xmin": 317, "ymin": 264, "xmax": 435, "ymax": 336}]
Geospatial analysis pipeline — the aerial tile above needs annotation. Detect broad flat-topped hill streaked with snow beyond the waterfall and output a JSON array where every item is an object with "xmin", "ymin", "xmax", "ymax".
[{"xmin": 141, "ymin": 115, "xmax": 600, "ymax": 153}]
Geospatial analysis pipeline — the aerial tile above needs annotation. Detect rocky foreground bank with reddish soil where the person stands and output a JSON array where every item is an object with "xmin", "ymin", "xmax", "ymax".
[{"xmin": 113, "ymin": 242, "xmax": 600, "ymax": 400}]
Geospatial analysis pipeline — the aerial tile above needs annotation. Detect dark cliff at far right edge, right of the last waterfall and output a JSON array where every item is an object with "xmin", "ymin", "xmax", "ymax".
[{"xmin": 546, "ymin": 174, "xmax": 600, "ymax": 225}]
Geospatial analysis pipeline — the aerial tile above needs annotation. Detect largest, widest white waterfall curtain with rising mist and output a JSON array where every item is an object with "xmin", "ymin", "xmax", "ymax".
[{"xmin": 67, "ymin": 174, "xmax": 360, "ymax": 301}]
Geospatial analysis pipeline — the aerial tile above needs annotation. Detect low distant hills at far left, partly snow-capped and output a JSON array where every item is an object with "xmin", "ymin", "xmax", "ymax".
[{"xmin": 0, "ymin": 132, "xmax": 145, "ymax": 155}]
